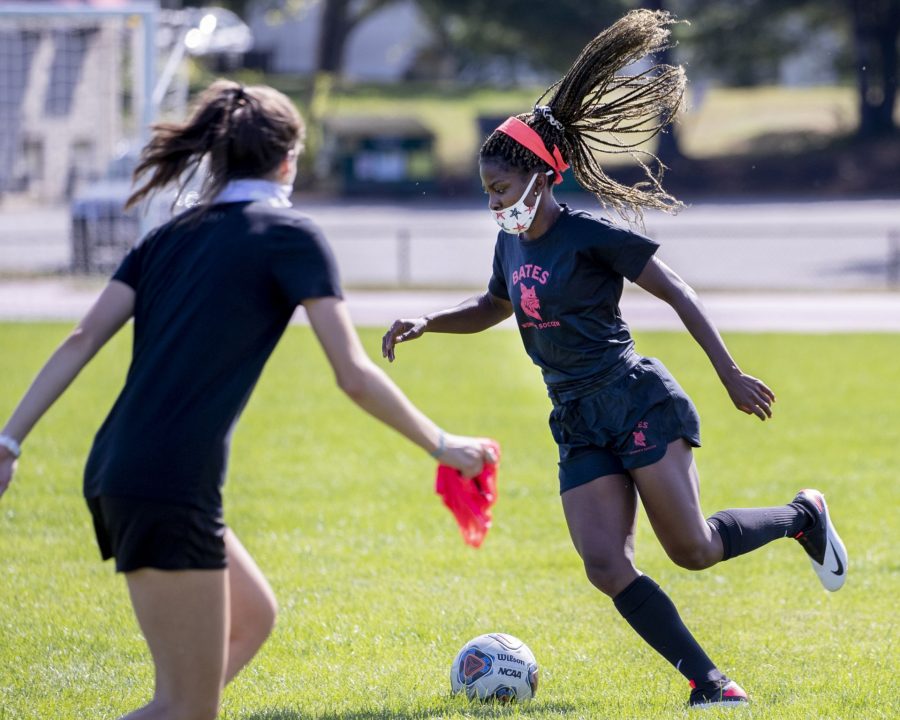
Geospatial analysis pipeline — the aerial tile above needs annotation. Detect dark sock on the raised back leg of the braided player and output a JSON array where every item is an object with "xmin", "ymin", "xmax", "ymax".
[{"xmin": 706, "ymin": 503, "xmax": 813, "ymax": 560}]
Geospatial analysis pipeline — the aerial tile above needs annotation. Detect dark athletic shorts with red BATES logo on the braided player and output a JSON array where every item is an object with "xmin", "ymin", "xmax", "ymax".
[{"xmin": 550, "ymin": 358, "xmax": 700, "ymax": 494}]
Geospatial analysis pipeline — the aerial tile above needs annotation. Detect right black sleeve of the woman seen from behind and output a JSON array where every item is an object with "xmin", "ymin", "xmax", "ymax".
[{"xmin": 268, "ymin": 221, "xmax": 343, "ymax": 305}]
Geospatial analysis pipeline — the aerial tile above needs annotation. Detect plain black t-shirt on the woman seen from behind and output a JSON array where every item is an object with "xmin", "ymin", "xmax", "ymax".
[{"xmin": 84, "ymin": 202, "xmax": 341, "ymax": 511}]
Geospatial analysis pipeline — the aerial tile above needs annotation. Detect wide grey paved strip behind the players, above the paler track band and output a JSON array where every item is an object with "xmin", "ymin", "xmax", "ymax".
[{"xmin": 0, "ymin": 197, "xmax": 900, "ymax": 292}]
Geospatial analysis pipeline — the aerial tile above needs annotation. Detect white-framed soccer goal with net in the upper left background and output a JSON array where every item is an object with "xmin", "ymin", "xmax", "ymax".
[{"xmin": 0, "ymin": 0, "xmax": 160, "ymax": 203}]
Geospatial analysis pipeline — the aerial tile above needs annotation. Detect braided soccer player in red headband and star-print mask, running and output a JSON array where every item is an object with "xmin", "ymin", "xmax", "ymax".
[{"xmin": 382, "ymin": 10, "xmax": 847, "ymax": 706}]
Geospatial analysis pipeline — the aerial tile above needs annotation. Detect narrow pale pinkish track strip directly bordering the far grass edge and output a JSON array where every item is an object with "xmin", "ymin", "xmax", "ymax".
[{"xmin": 0, "ymin": 279, "xmax": 900, "ymax": 332}]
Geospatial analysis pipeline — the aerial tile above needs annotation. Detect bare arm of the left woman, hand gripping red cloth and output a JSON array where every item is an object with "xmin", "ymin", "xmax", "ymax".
[{"xmin": 303, "ymin": 297, "xmax": 496, "ymax": 477}]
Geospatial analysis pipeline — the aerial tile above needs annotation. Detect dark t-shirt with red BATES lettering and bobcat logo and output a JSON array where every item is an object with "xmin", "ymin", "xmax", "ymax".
[{"xmin": 488, "ymin": 205, "xmax": 659, "ymax": 388}]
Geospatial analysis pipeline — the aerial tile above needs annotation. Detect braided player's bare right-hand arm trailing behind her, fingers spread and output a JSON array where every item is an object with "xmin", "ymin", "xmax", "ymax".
[{"xmin": 635, "ymin": 257, "xmax": 775, "ymax": 420}]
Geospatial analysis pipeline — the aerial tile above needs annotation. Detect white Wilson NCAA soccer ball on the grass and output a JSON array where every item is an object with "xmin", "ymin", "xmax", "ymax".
[{"xmin": 450, "ymin": 633, "xmax": 538, "ymax": 703}]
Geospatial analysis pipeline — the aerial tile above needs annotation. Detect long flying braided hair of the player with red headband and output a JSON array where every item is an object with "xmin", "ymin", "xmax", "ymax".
[{"xmin": 480, "ymin": 10, "xmax": 686, "ymax": 220}]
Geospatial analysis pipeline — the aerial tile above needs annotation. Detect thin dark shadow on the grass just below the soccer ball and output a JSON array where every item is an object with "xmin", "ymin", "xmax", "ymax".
[{"xmin": 241, "ymin": 703, "xmax": 575, "ymax": 720}]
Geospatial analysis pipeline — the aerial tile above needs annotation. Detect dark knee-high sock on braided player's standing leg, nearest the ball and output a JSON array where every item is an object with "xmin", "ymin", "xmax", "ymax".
[{"xmin": 613, "ymin": 575, "xmax": 722, "ymax": 684}]
